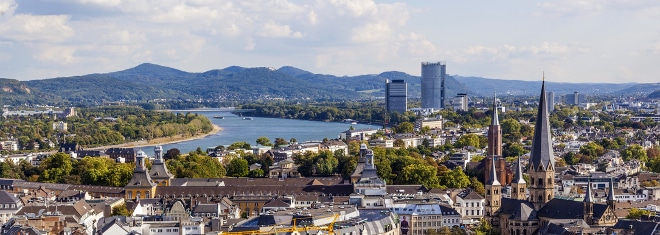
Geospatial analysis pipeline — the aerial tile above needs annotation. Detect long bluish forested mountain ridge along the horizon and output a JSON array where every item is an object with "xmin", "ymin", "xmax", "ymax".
[{"xmin": 0, "ymin": 63, "xmax": 660, "ymax": 104}]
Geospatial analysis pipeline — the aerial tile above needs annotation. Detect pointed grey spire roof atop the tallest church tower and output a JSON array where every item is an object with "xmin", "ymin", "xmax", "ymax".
[{"xmin": 529, "ymin": 81, "xmax": 555, "ymax": 169}]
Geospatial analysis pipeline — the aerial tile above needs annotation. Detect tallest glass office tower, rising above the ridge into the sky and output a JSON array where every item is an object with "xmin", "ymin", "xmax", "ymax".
[{"xmin": 422, "ymin": 62, "xmax": 447, "ymax": 109}]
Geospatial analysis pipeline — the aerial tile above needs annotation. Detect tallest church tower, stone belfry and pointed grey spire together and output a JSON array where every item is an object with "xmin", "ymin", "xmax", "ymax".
[{"xmin": 527, "ymin": 77, "xmax": 555, "ymax": 210}]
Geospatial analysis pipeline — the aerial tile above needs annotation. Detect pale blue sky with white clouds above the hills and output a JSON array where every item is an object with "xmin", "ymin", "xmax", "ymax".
[{"xmin": 0, "ymin": 0, "xmax": 660, "ymax": 83}]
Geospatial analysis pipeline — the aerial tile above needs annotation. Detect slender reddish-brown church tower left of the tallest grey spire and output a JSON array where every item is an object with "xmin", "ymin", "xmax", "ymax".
[{"xmin": 483, "ymin": 93, "xmax": 511, "ymax": 185}]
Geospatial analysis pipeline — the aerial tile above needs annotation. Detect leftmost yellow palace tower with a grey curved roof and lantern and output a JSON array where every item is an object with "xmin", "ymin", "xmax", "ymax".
[{"xmin": 124, "ymin": 150, "xmax": 156, "ymax": 200}]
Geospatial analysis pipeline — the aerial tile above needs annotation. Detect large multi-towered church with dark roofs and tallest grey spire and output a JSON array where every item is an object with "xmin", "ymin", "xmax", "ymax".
[{"xmin": 485, "ymin": 81, "xmax": 618, "ymax": 235}]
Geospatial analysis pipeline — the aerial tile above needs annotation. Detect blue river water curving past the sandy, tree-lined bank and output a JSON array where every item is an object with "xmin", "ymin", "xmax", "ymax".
[{"xmin": 155, "ymin": 111, "xmax": 380, "ymax": 153}]
